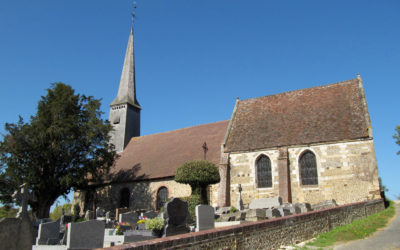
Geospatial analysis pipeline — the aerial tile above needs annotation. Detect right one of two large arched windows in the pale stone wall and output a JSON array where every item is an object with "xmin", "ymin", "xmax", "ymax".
[{"xmin": 299, "ymin": 150, "xmax": 318, "ymax": 185}]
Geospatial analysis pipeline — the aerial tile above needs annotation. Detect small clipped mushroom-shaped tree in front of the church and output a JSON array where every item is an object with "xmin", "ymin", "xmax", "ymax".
[{"xmin": 175, "ymin": 160, "xmax": 220, "ymax": 204}]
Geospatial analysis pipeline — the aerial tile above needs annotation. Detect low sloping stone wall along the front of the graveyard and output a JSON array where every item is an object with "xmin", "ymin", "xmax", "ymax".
[{"xmin": 98, "ymin": 200, "xmax": 384, "ymax": 250}]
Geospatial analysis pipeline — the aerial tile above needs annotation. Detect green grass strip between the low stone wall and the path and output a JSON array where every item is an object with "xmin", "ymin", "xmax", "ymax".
[{"xmin": 300, "ymin": 201, "xmax": 395, "ymax": 249}]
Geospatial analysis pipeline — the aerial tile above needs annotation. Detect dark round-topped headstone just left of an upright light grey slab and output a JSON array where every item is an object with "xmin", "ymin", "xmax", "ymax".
[{"xmin": 163, "ymin": 198, "xmax": 190, "ymax": 236}]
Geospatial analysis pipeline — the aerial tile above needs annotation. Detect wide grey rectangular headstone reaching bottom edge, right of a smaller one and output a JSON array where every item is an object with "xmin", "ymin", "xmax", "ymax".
[{"xmin": 67, "ymin": 220, "xmax": 104, "ymax": 249}]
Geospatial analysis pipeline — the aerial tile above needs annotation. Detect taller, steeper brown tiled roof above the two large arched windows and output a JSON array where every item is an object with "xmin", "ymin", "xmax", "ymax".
[{"xmin": 225, "ymin": 79, "xmax": 369, "ymax": 152}]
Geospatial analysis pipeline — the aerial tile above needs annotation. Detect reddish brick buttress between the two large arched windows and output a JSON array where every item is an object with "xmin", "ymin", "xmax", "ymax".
[{"xmin": 278, "ymin": 147, "xmax": 292, "ymax": 203}]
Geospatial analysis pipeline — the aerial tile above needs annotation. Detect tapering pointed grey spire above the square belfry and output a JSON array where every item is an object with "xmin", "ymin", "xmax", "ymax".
[{"xmin": 110, "ymin": 27, "xmax": 141, "ymax": 109}]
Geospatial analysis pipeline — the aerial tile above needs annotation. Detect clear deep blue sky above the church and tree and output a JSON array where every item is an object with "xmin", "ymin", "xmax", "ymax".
[{"xmin": 0, "ymin": 0, "xmax": 400, "ymax": 205}]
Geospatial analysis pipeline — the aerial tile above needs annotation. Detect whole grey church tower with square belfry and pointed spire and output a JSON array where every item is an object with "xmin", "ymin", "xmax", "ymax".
[{"xmin": 108, "ymin": 26, "xmax": 142, "ymax": 152}]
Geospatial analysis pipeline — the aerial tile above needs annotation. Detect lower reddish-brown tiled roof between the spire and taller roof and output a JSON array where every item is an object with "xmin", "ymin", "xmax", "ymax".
[{"xmin": 108, "ymin": 121, "xmax": 229, "ymax": 182}]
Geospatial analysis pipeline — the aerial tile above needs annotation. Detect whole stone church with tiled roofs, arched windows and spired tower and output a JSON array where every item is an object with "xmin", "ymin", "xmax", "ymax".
[{"xmin": 74, "ymin": 29, "xmax": 380, "ymax": 214}]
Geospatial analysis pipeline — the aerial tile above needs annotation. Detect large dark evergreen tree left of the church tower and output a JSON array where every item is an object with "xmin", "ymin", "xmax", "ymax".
[{"xmin": 0, "ymin": 83, "xmax": 116, "ymax": 218}]
